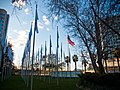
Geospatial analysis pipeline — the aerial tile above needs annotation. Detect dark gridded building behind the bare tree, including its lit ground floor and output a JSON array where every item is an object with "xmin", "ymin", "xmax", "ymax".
[{"xmin": 100, "ymin": 14, "xmax": 120, "ymax": 71}]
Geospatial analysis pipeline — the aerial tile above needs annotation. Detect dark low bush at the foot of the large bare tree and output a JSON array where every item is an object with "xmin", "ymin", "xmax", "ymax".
[{"xmin": 78, "ymin": 73, "xmax": 120, "ymax": 90}]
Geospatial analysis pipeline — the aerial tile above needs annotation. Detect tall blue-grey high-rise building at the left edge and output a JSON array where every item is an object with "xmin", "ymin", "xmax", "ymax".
[{"xmin": 0, "ymin": 9, "xmax": 9, "ymax": 67}]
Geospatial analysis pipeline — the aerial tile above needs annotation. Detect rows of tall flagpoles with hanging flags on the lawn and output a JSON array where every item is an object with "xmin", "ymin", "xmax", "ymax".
[{"xmin": 21, "ymin": 5, "xmax": 75, "ymax": 90}]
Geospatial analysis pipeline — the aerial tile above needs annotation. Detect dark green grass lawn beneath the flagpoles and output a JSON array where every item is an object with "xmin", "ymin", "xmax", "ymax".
[{"xmin": 0, "ymin": 76, "xmax": 78, "ymax": 90}]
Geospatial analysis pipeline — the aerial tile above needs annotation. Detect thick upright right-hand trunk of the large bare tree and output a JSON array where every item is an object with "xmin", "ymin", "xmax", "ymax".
[{"xmin": 90, "ymin": 0, "xmax": 105, "ymax": 74}]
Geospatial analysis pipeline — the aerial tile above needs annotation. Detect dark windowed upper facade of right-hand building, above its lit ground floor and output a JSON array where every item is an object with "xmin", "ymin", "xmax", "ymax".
[{"xmin": 101, "ymin": 14, "xmax": 120, "ymax": 58}]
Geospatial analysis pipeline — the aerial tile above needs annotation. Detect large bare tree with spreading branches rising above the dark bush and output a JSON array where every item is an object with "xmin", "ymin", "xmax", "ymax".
[{"xmin": 44, "ymin": 0, "xmax": 119, "ymax": 74}]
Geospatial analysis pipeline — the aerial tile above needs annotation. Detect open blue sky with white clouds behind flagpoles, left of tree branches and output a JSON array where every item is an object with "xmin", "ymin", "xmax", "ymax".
[{"xmin": 0, "ymin": 0, "xmax": 81, "ymax": 69}]
